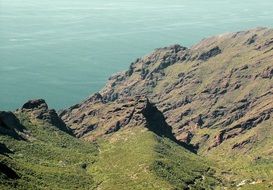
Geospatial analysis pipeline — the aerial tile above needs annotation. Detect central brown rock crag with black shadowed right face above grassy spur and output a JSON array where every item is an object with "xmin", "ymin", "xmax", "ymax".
[{"xmin": 61, "ymin": 96, "xmax": 176, "ymax": 140}]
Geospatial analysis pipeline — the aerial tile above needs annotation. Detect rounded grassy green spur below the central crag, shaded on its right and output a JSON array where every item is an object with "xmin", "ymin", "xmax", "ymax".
[{"xmin": 89, "ymin": 127, "xmax": 218, "ymax": 189}]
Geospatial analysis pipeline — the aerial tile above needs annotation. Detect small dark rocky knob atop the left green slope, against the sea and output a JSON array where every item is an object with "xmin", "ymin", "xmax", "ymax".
[{"xmin": 18, "ymin": 99, "xmax": 72, "ymax": 134}]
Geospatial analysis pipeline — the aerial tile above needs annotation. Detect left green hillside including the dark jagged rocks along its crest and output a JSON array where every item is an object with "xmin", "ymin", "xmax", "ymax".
[{"xmin": 0, "ymin": 100, "xmax": 97, "ymax": 190}]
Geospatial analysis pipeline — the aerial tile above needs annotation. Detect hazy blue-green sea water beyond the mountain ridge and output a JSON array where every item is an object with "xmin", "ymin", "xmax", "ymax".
[{"xmin": 0, "ymin": 0, "xmax": 273, "ymax": 110}]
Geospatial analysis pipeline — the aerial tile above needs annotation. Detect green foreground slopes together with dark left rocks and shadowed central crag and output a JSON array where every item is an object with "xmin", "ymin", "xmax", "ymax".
[{"xmin": 0, "ymin": 98, "xmax": 221, "ymax": 190}]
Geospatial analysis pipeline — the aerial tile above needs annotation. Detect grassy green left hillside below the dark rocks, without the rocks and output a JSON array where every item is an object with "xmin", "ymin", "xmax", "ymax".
[{"xmin": 0, "ymin": 113, "xmax": 97, "ymax": 190}]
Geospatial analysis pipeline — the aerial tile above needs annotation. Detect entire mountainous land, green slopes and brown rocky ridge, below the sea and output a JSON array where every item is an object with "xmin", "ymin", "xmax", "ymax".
[{"xmin": 0, "ymin": 28, "xmax": 273, "ymax": 190}]
